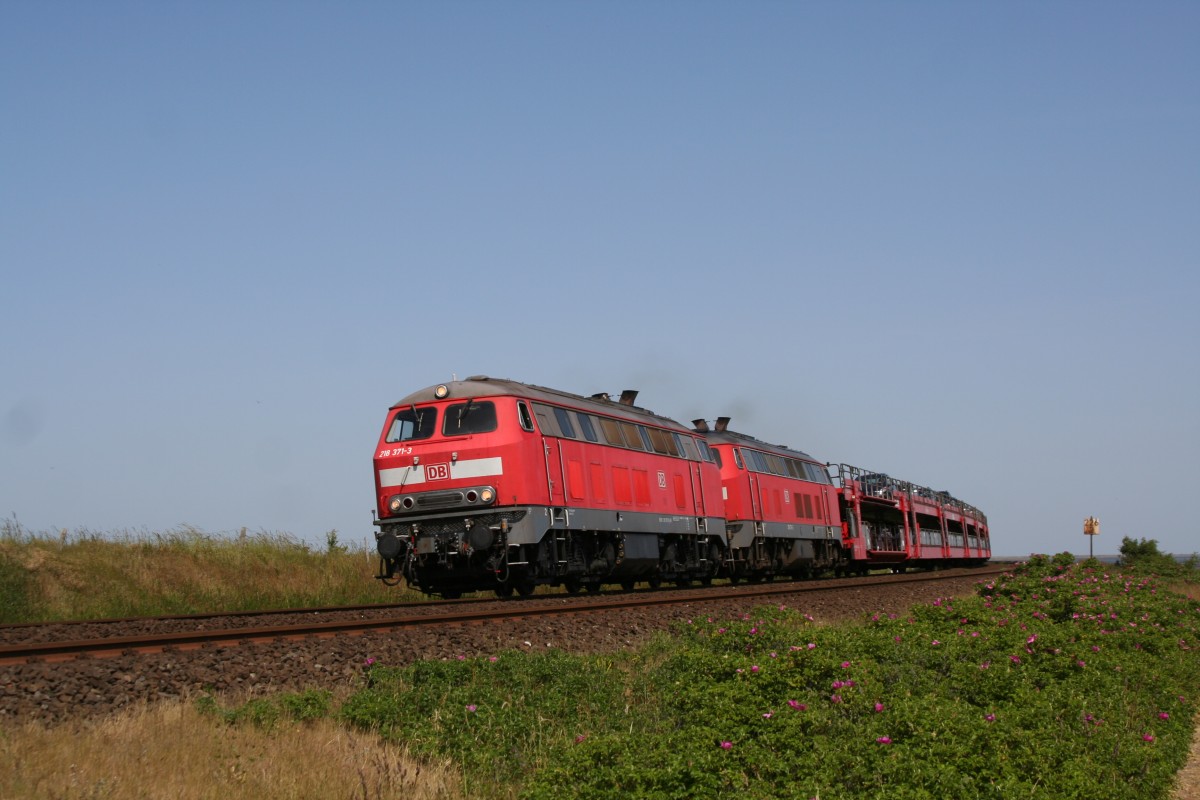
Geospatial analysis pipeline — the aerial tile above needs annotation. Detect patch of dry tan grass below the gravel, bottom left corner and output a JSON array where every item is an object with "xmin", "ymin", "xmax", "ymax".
[{"xmin": 0, "ymin": 703, "xmax": 462, "ymax": 800}]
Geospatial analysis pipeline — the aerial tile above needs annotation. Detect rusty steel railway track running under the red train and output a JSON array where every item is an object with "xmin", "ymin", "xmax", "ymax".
[{"xmin": 0, "ymin": 564, "xmax": 1009, "ymax": 666}]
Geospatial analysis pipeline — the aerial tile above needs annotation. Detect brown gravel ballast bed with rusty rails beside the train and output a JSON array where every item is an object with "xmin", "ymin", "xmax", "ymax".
[{"xmin": 0, "ymin": 570, "xmax": 1003, "ymax": 721}]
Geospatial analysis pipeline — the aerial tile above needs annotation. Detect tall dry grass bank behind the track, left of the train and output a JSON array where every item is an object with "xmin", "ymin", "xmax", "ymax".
[{"xmin": 0, "ymin": 522, "xmax": 420, "ymax": 622}]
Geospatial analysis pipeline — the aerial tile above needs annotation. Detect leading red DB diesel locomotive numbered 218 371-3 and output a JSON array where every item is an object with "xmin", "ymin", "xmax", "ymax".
[{"xmin": 374, "ymin": 375, "xmax": 726, "ymax": 597}]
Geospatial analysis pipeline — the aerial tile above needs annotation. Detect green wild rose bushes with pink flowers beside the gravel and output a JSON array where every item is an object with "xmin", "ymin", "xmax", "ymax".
[{"xmin": 343, "ymin": 554, "xmax": 1200, "ymax": 800}]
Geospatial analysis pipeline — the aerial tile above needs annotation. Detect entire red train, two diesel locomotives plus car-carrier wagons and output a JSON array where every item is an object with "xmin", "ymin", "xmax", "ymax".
[{"xmin": 374, "ymin": 375, "xmax": 990, "ymax": 597}]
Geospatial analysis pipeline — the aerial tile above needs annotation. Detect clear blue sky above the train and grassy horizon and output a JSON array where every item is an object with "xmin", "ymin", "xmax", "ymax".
[{"xmin": 0, "ymin": 0, "xmax": 1200, "ymax": 555}]
